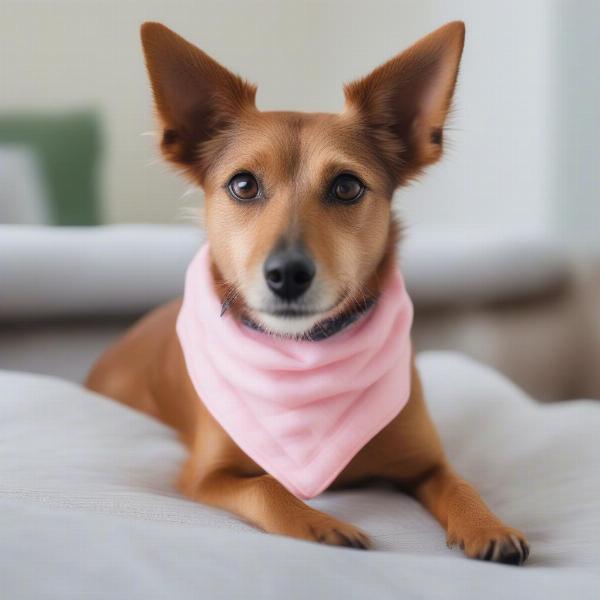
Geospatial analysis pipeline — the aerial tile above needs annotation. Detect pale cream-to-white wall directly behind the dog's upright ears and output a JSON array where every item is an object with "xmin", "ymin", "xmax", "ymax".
[{"xmin": 0, "ymin": 0, "xmax": 554, "ymax": 231}]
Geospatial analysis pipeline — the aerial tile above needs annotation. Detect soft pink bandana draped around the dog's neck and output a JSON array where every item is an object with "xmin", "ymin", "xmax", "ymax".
[{"xmin": 177, "ymin": 245, "xmax": 413, "ymax": 498}]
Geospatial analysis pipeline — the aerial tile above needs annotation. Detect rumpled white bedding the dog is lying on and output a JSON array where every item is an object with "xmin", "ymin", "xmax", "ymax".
[{"xmin": 0, "ymin": 353, "xmax": 600, "ymax": 600}]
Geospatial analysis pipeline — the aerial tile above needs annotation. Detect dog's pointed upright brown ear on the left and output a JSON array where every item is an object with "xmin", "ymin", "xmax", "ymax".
[{"xmin": 141, "ymin": 23, "xmax": 256, "ymax": 179}]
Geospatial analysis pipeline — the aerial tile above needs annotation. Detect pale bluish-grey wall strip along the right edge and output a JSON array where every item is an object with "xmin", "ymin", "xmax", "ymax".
[{"xmin": 548, "ymin": 0, "xmax": 600, "ymax": 250}]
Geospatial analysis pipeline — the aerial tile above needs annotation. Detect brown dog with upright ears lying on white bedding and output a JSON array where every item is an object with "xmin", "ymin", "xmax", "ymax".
[{"xmin": 87, "ymin": 22, "xmax": 529, "ymax": 564}]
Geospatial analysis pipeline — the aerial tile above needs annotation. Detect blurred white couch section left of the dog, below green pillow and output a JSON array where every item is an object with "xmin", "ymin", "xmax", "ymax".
[{"xmin": 0, "ymin": 225, "xmax": 202, "ymax": 320}]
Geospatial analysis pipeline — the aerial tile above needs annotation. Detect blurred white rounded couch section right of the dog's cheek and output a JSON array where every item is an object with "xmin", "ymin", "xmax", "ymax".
[{"xmin": 400, "ymin": 228, "xmax": 572, "ymax": 308}]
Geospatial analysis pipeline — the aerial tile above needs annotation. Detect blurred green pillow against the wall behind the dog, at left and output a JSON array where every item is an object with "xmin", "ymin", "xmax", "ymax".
[{"xmin": 0, "ymin": 110, "xmax": 101, "ymax": 225}]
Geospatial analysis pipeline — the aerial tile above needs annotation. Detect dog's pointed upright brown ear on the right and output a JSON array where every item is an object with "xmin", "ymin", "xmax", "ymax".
[{"xmin": 344, "ymin": 21, "xmax": 465, "ymax": 185}]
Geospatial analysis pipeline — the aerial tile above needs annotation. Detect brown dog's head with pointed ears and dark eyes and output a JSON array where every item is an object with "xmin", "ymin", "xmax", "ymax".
[{"xmin": 142, "ymin": 22, "xmax": 464, "ymax": 336}]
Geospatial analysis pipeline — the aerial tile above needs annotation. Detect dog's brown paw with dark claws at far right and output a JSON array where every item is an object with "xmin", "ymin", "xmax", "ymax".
[{"xmin": 448, "ymin": 527, "xmax": 529, "ymax": 565}]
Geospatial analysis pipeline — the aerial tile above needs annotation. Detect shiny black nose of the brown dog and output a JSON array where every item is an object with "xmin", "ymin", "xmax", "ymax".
[{"xmin": 264, "ymin": 248, "xmax": 315, "ymax": 301}]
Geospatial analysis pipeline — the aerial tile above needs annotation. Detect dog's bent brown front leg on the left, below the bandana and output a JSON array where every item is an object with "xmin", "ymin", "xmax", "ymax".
[{"xmin": 180, "ymin": 414, "xmax": 371, "ymax": 549}]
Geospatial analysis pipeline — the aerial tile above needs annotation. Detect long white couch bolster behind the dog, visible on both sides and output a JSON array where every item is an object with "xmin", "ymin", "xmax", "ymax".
[{"xmin": 0, "ymin": 225, "xmax": 569, "ymax": 319}]
